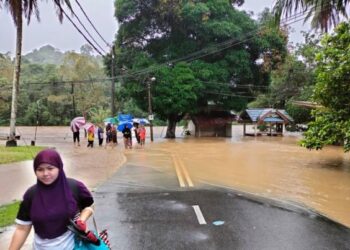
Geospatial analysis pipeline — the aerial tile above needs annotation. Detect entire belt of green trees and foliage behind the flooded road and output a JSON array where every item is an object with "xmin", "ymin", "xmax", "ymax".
[{"xmin": 0, "ymin": 0, "xmax": 350, "ymax": 150}]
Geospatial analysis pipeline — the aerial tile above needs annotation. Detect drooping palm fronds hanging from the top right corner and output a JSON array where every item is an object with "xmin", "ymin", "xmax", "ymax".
[{"xmin": 274, "ymin": 0, "xmax": 350, "ymax": 32}]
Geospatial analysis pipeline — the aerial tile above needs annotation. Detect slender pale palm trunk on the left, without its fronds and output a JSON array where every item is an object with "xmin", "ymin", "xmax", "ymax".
[{"xmin": 7, "ymin": 8, "xmax": 22, "ymax": 146}]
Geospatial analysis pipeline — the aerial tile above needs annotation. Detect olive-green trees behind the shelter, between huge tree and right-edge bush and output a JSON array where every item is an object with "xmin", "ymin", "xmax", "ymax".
[{"xmin": 248, "ymin": 36, "xmax": 319, "ymax": 123}]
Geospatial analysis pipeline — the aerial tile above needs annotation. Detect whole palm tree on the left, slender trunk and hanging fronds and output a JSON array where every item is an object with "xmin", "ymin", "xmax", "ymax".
[{"xmin": 0, "ymin": 0, "xmax": 71, "ymax": 146}]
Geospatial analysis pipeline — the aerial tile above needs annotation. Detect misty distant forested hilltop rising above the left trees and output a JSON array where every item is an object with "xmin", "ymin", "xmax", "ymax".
[{"xmin": 23, "ymin": 45, "xmax": 64, "ymax": 65}]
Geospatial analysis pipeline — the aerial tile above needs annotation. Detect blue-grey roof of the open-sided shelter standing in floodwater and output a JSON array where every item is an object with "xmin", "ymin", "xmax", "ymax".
[{"xmin": 240, "ymin": 108, "xmax": 294, "ymax": 123}]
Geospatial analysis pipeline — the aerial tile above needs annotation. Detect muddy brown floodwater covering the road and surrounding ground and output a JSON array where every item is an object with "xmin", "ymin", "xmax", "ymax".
[{"xmin": 0, "ymin": 126, "xmax": 350, "ymax": 227}]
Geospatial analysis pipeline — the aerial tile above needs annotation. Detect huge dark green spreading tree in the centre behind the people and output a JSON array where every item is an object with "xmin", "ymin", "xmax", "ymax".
[{"xmin": 112, "ymin": 0, "xmax": 287, "ymax": 138}]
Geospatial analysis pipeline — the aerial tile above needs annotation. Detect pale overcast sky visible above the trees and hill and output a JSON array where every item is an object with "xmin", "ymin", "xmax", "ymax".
[{"xmin": 0, "ymin": 0, "xmax": 308, "ymax": 55}]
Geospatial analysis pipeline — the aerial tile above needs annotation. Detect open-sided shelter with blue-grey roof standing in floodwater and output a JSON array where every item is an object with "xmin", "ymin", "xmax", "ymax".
[{"xmin": 239, "ymin": 108, "xmax": 294, "ymax": 136}]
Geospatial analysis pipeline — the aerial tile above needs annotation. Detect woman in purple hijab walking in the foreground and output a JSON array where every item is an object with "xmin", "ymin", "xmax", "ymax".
[{"xmin": 9, "ymin": 149, "xmax": 94, "ymax": 250}]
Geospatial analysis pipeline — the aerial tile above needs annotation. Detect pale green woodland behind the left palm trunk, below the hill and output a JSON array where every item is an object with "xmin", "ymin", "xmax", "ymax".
[{"xmin": 0, "ymin": 47, "xmax": 110, "ymax": 125}]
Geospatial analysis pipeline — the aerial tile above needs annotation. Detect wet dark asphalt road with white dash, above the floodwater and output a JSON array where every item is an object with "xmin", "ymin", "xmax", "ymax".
[{"xmin": 94, "ymin": 164, "xmax": 350, "ymax": 250}]
